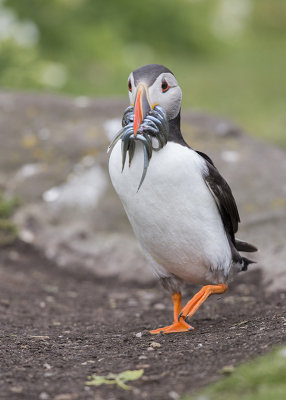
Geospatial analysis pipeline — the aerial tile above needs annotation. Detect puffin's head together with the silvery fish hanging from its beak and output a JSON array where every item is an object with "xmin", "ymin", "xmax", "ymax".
[{"xmin": 107, "ymin": 64, "xmax": 182, "ymax": 190}]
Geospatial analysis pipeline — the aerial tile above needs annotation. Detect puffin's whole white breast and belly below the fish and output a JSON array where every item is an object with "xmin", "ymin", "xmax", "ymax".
[{"xmin": 109, "ymin": 142, "xmax": 231, "ymax": 284}]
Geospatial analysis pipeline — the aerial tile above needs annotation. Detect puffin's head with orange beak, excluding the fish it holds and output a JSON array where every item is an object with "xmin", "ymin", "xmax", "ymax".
[{"xmin": 128, "ymin": 64, "xmax": 182, "ymax": 134}]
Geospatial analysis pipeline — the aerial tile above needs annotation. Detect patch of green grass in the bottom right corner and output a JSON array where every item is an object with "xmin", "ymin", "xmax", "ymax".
[{"xmin": 181, "ymin": 347, "xmax": 286, "ymax": 400}]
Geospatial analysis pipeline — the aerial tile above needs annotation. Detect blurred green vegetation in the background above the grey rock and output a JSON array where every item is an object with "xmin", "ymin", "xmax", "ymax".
[{"xmin": 0, "ymin": 0, "xmax": 286, "ymax": 147}]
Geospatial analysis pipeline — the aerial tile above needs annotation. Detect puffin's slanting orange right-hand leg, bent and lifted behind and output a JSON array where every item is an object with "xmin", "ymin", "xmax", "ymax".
[{"xmin": 178, "ymin": 283, "xmax": 227, "ymax": 320}]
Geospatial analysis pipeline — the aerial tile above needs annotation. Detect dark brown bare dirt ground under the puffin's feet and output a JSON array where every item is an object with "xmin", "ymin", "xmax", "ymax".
[{"xmin": 0, "ymin": 242, "xmax": 286, "ymax": 400}]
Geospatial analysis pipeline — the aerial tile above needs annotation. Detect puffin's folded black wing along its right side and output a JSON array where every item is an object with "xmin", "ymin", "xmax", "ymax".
[{"xmin": 197, "ymin": 152, "xmax": 240, "ymax": 245}]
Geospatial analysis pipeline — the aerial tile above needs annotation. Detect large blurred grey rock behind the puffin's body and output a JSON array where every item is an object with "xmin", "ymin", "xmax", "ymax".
[{"xmin": 0, "ymin": 92, "xmax": 286, "ymax": 290}]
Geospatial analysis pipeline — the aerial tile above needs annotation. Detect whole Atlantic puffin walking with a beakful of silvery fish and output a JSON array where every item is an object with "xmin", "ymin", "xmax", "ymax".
[{"xmin": 109, "ymin": 64, "xmax": 257, "ymax": 334}]
